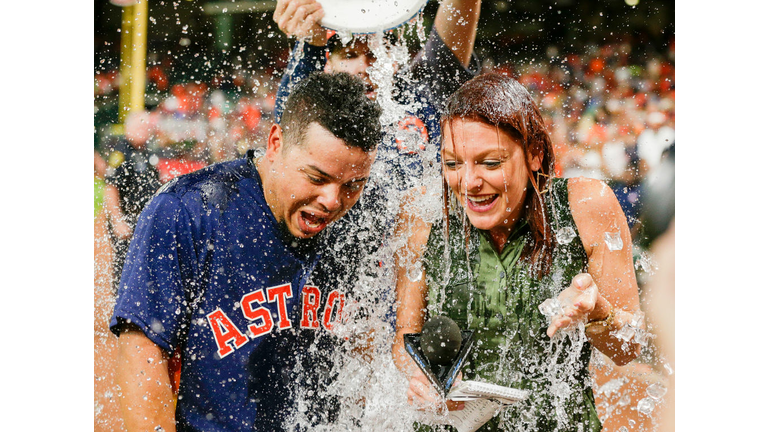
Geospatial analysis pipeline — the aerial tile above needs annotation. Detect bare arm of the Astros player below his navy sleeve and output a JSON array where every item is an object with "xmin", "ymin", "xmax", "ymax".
[{"xmin": 116, "ymin": 327, "xmax": 176, "ymax": 432}]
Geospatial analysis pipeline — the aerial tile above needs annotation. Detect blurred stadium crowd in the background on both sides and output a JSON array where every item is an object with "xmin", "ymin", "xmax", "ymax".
[{"xmin": 94, "ymin": 37, "xmax": 675, "ymax": 233}]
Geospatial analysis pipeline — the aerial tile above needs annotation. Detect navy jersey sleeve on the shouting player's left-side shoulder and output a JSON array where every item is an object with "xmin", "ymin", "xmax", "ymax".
[{"xmin": 110, "ymin": 194, "xmax": 202, "ymax": 352}]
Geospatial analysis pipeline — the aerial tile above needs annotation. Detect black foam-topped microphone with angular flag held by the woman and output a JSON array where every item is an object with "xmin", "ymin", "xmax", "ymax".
[{"xmin": 403, "ymin": 316, "xmax": 474, "ymax": 396}]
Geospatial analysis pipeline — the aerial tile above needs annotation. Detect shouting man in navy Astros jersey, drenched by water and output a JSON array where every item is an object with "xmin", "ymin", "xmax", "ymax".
[{"xmin": 110, "ymin": 73, "xmax": 381, "ymax": 432}]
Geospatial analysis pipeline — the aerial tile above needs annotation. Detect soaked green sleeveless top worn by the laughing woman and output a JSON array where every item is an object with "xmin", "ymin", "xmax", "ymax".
[{"xmin": 424, "ymin": 179, "xmax": 601, "ymax": 432}]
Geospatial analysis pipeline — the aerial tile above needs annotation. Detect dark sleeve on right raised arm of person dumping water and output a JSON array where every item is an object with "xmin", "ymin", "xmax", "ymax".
[{"xmin": 410, "ymin": 27, "xmax": 480, "ymax": 110}]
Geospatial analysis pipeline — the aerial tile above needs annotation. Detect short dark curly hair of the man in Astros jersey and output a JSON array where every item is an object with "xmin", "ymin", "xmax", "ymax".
[{"xmin": 280, "ymin": 72, "xmax": 382, "ymax": 152}]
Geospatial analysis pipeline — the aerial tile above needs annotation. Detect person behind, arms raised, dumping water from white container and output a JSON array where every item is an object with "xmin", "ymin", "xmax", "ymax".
[{"xmin": 273, "ymin": 0, "xmax": 480, "ymax": 336}]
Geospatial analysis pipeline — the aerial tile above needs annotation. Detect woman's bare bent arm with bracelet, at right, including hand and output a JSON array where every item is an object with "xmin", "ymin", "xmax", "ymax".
[{"xmin": 547, "ymin": 178, "xmax": 644, "ymax": 365}]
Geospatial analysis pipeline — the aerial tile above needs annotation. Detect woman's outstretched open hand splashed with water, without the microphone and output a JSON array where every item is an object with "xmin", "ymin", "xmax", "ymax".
[{"xmin": 547, "ymin": 273, "xmax": 611, "ymax": 337}]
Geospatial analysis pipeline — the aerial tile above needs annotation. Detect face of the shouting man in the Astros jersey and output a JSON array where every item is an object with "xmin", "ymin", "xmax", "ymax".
[{"xmin": 262, "ymin": 123, "xmax": 376, "ymax": 238}]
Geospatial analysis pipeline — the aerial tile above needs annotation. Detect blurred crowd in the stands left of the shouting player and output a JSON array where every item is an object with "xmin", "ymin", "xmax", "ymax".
[{"xmin": 95, "ymin": 62, "xmax": 279, "ymax": 177}]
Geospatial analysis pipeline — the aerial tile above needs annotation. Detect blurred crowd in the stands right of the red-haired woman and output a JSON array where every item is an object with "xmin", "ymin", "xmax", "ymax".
[{"xmin": 488, "ymin": 41, "xmax": 675, "ymax": 231}]
